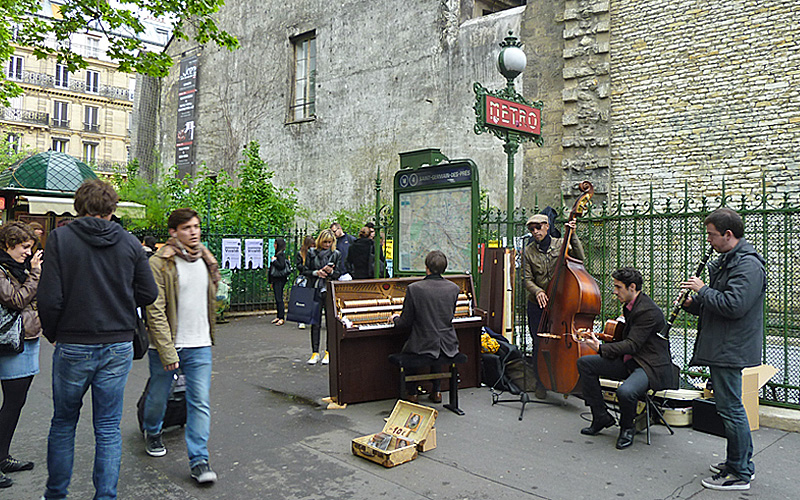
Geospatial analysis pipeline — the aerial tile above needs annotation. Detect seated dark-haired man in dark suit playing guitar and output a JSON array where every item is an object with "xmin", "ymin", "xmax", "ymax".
[{"xmin": 576, "ymin": 267, "xmax": 676, "ymax": 450}]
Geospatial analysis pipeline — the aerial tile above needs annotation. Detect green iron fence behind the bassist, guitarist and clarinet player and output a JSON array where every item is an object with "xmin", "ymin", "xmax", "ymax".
[{"xmin": 479, "ymin": 180, "xmax": 800, "ymax": 408}]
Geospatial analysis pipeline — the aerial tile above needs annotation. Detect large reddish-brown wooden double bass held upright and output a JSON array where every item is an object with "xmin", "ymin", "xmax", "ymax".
[{"xmin": 537, "ymin": 181, "xmax": 601, "ymax": 394}]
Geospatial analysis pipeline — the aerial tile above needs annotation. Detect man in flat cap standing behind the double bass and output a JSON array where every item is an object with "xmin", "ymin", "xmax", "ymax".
[{"xmin": 522, "ymin": 214, "xmax": 584, "ymax": 399}]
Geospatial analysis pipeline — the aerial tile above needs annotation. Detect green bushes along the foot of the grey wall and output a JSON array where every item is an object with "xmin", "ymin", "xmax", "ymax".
[{"xmin": 115, "ymin": 141, "xmax": 297, "ymax": 232}]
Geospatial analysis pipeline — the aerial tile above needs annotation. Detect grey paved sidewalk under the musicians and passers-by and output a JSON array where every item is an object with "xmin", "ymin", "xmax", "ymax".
[{"xmin": 7, "ymin": 316, "xmax": 800, "ymax": 500}]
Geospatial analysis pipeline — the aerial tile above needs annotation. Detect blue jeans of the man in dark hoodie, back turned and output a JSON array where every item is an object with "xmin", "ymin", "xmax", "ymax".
[{"xmin": 45, "ymin": 342, "xmax": 133, "ymax": 500}]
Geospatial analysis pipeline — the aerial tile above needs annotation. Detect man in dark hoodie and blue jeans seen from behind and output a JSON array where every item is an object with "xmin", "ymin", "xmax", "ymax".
[{"xmin": 37, "ymin": 179, "xmax": 158, "ymax": 500}]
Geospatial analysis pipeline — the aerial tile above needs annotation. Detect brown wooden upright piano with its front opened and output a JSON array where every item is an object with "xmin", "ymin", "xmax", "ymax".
[{"xmin": 325, "ymin": 275, "xmax": 486, "ymax": 404}]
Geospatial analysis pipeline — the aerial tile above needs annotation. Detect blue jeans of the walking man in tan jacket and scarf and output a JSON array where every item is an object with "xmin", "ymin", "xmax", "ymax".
[{"xmin": 143, "ymin": 347, "xmax": 211, "ymax": 467}]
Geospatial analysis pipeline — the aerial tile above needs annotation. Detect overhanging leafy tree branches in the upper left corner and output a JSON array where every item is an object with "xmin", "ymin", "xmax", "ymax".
[{"xmin": 0, "ymin": 0, "xmax": 239, "ymax": 106}]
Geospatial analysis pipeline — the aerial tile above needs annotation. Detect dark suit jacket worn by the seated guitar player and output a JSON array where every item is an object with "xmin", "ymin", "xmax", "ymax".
[{"xmin": 600, "ymin": 292, "xmax": 676, "ymax": 391}]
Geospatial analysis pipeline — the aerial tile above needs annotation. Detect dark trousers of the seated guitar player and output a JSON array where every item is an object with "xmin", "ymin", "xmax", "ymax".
[{"xmin": 578, "ymin": 354, "xmax": 650, "ymax": 429}]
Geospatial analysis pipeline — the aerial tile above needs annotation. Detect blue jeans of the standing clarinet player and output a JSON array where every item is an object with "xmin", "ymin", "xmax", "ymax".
[{"xmin": 709, "ymin": 366, "xmax": 756, "ymax": 481}]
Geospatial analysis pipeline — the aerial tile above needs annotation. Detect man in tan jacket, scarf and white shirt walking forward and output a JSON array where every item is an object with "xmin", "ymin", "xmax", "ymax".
[{"xmin": 142, "ymin": 208, "xmax": 220, "ymax": 484}]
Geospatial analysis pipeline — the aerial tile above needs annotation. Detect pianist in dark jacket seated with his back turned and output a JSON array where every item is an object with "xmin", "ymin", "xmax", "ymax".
[{"xmin": 391, "ymin": 250, "xmax": 459, "ymax": 403}]
